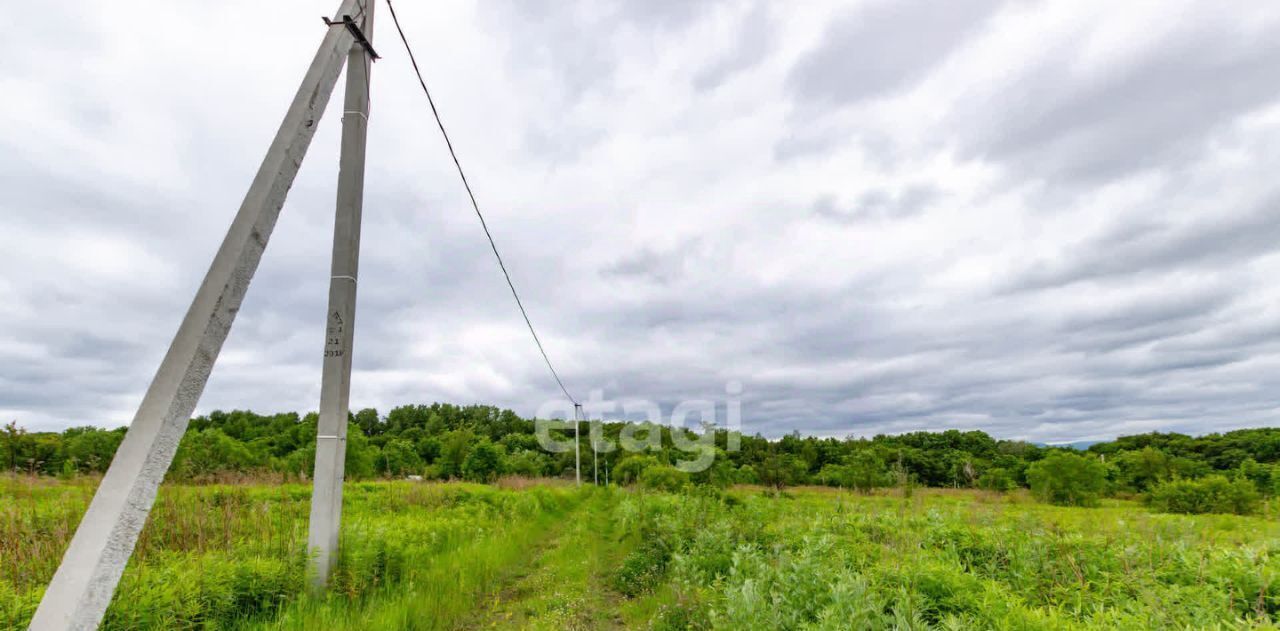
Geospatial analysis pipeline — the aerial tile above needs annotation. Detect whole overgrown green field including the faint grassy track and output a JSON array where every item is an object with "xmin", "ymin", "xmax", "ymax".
[{"xmin": 0, "ymin": 477, "xmax": 1280, "ymax": 631}]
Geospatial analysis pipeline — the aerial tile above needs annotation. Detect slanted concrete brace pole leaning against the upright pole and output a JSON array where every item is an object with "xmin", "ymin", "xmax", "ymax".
[{"xmin": 29, "ymin": 0, "xmax": 357, "ymax": 631}]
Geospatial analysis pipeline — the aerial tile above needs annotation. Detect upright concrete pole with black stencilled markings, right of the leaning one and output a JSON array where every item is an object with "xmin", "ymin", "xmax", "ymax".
[{"xmin": 307, "ymin": 0, "xmax": 374, "ymax": 591}]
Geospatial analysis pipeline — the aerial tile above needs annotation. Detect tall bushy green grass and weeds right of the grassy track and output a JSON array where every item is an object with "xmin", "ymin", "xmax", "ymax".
[{"xmin": 618, "ymin": 483, "xmax": 1280, "ymax": 630}]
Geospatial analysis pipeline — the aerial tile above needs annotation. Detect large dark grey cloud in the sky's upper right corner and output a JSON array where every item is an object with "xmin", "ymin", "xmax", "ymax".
[{"xmin": 950, "ymin": 15, "xmax": 1280, "ymax": 182}]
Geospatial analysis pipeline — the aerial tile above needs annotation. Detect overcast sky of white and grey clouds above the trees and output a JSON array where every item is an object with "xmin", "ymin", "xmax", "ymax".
[{"xmin": 0, "ymin": 0, "xmax": 1280, "ymax": 440}]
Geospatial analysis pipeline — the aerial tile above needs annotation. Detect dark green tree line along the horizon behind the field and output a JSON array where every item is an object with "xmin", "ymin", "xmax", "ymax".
[{"xmin": 0, "ymin": 403, "xmax": 1280, "ymax": 512}]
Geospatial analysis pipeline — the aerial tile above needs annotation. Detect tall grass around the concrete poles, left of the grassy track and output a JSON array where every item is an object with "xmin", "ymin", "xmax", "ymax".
[{"xmin": 0, "ymin": 477, "xmax": 577, "ymax": 630}]
